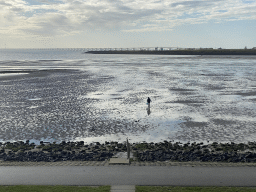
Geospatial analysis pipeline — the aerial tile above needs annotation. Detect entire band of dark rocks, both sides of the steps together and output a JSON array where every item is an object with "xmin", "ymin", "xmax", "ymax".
[{"xmin": 0, "ymin": 140, "xmax": 256, "ymax": 163}]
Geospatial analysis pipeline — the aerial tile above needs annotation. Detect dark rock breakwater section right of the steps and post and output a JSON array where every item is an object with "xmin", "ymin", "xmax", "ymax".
[{"xmin": 134, "ymin": 141, "xmax": 256, "ymax": 163}]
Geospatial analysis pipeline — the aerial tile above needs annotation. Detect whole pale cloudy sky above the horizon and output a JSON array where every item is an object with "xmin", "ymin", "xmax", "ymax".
[{"xmin": 0, "ymin": 0, "xmax": 256, "ymax": 49}]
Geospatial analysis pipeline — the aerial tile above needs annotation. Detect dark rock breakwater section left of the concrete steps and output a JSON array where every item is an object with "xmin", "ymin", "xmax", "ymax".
[{"xmin": 0, "ymin": 141, "xmax": 113, "ymax": 162}]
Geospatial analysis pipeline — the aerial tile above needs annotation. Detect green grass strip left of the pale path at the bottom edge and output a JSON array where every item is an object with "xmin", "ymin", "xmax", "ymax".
[{"xmin": 0, "ymin": 185, "xmax": 110, "ymax": 192}]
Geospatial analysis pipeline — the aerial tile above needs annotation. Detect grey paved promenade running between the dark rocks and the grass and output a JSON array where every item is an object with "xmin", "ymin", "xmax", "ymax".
[{"xmin": 0, "ymin": 162, "xmax": 256, "ymax": 186}]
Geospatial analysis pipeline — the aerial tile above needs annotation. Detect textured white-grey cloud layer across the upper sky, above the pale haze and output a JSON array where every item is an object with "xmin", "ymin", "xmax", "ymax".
[{"xmin": 0, "ymin": 0, "xmax": 256, "ymax": 36}]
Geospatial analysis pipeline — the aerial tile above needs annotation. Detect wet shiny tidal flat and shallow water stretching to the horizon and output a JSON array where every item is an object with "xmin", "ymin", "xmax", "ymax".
[{"xmin": 0, "ymin": 49, "xmax": 256, "ymax": 143}]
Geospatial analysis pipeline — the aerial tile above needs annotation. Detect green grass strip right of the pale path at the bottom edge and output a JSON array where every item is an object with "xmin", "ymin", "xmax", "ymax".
[{"xmin": 136, "ymin": 186, "xmax": 256, "ymax": 192}]
